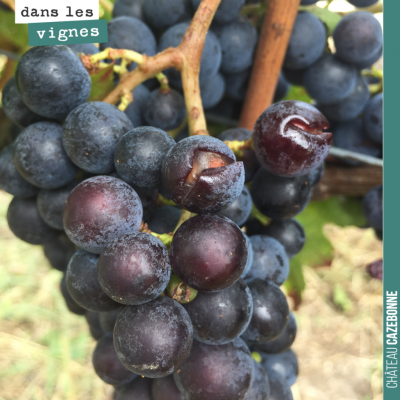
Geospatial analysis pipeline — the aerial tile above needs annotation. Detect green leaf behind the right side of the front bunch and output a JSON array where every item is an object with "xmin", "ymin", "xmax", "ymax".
[{"xmin": 284, "ymin": 196, "xmax": 366, "ymax": 300}]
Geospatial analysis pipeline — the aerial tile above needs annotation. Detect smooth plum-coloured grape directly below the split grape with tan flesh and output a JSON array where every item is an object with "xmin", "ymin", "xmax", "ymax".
[{"xmin": 170, "ymin": 215, "xmax": 248, "ymax": 291}]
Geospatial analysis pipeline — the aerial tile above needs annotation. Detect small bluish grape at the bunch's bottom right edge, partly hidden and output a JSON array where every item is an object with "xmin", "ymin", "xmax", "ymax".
[{"xmin": 261, "ymin": 349, "xmax": 299, "ymax": 386}]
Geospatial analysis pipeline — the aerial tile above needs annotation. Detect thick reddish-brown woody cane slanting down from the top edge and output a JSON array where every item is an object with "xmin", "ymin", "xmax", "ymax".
[{"xmin": 239, "ymin": 0, "xmax": 300, "ymax": 130}]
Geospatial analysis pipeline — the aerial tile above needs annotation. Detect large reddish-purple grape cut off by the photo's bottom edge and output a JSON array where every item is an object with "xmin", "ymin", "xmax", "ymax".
[{"xmin": 174, "ymin": 339, "xmax": 253, "ymax": 400}]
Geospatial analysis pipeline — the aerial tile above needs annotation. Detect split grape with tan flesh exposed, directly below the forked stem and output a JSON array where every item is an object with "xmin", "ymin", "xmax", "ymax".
[{"xmin": 162, "ymin": 135, "xmax": 244, "ymax": 214}]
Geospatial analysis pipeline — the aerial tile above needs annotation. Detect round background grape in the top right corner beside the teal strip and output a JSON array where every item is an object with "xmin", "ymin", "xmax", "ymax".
[{"xmin": 333, "ymin": 11, "xmax": 383, "ymax": 67}]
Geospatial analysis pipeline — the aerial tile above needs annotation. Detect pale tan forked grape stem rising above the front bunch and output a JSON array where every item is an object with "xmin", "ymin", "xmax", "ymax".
[{"xmin": 87, "ymin": 0, "xmax": 221, "ymax": 135}]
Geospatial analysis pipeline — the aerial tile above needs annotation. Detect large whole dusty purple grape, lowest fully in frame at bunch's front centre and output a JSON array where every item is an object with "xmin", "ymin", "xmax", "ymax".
[{"xmin": 114, "ymin": 296, "xmax": 193, "ymax": 378}]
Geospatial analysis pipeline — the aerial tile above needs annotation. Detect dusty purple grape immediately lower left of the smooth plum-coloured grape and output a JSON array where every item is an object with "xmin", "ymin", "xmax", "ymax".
[{"xmin": 98, "ymin": 232, "xmax": 171, "ymax": 305}]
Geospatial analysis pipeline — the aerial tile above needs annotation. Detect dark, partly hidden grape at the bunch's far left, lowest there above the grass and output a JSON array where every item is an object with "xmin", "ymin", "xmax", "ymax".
[{"xmin": 7, "ymin": 197, "xmax": 60, "ymax": 244}]
